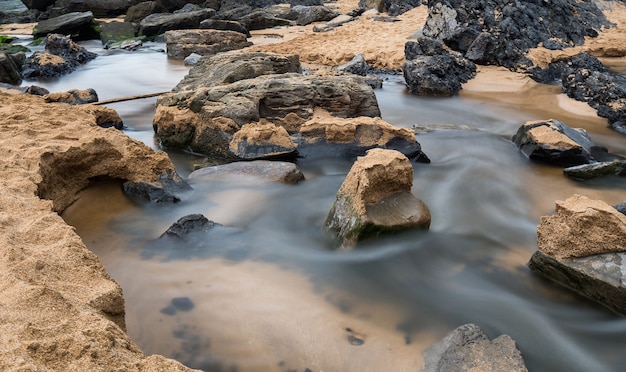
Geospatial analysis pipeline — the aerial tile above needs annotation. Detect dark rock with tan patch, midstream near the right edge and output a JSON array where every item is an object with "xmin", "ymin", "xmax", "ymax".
[{"xmin": 512, "ymin": 119, "xmax": 601, "ymax": 166}]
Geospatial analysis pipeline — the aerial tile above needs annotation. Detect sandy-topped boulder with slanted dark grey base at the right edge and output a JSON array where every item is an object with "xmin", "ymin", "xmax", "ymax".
[{"xmin": 529, "ymin": 195, "xmax": 626, "ymax": 314}]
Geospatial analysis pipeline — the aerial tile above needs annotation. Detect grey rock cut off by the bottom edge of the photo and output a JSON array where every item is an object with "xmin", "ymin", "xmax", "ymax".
[{"xmin": 423, "ymin": 324, "xmax": 528, "ymax": 372}]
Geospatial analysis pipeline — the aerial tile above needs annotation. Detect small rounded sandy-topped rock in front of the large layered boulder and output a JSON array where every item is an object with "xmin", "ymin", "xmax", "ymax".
[{"xmin": 230, "ymin": 121, "xmax": 298, "ymax": 160}]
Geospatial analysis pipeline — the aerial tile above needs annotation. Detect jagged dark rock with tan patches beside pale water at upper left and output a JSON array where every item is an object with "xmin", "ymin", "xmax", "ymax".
[{"xmin": 22, "ymin": 34, "xmax": 97, "ymax": 79}]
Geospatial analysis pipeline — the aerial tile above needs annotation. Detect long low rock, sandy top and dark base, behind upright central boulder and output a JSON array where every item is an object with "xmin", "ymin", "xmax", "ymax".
[{"xmin": 292, "ymin": 117, "xmax": 430, "ymax": 163}]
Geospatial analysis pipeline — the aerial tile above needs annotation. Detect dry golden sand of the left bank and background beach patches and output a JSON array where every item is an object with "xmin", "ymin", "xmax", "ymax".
[{"xmin": 0, "ymin": 0, "xmax": 626, "ymax": 371}]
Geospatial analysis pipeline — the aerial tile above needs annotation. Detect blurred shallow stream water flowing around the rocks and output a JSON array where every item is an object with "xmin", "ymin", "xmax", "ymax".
[{"xmin": 15, "ymin": 38, "xmax": 626, "ymax": 372}]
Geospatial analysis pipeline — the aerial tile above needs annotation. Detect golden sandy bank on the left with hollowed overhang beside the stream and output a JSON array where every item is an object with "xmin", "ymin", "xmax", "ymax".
[{"xmin": 0, "ymin": 94, "xmax": 194, "ymax": 371}]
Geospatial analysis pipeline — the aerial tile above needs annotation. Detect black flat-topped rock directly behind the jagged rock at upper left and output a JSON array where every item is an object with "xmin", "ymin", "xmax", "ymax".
[{"xmin": 33, "ymin": 11, "xmax": 98, "ymax": 40}]
